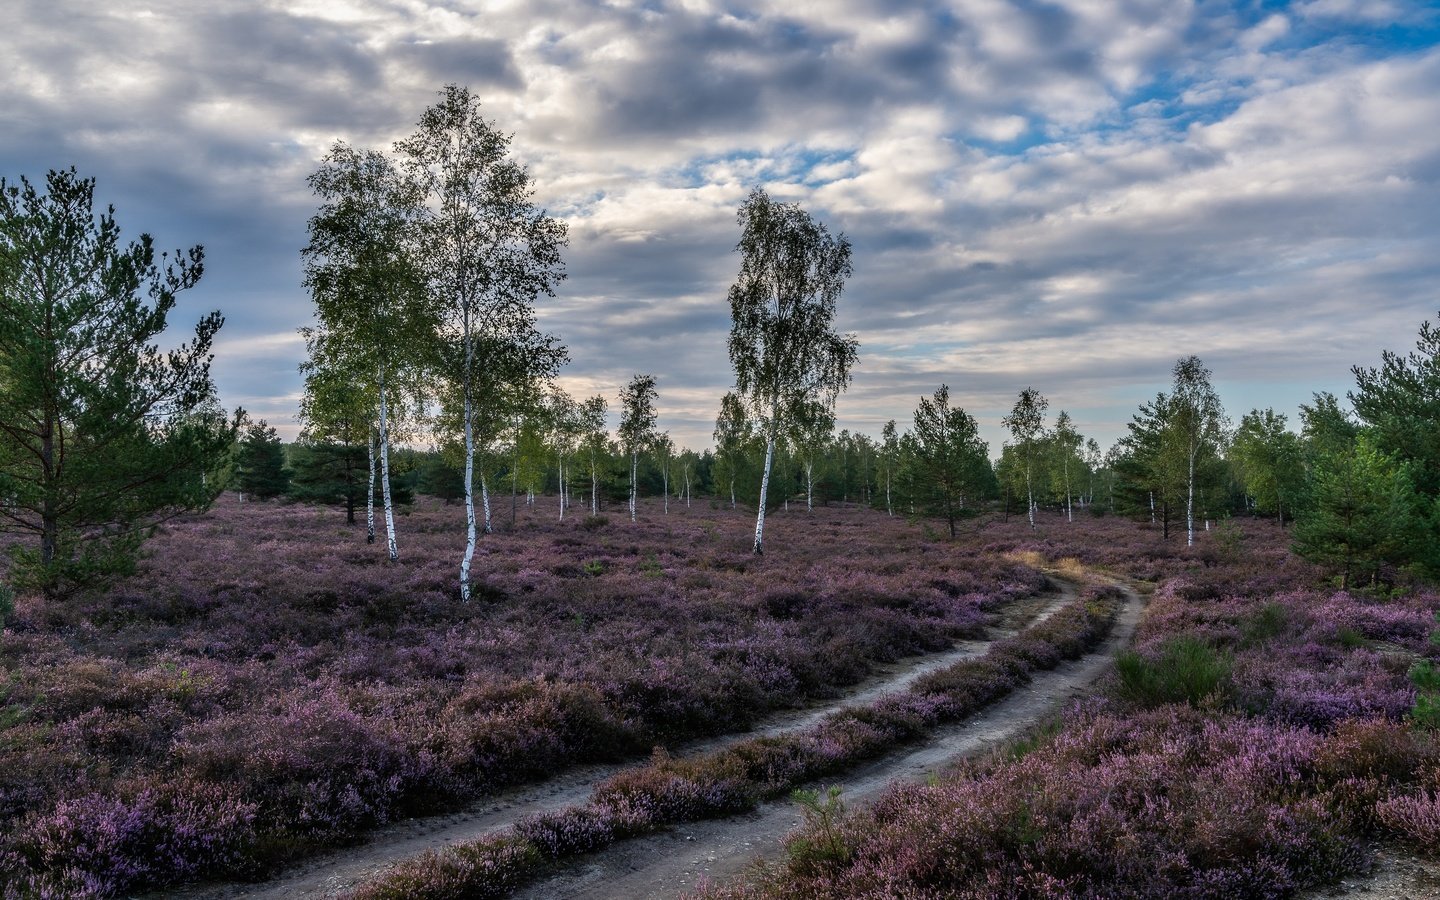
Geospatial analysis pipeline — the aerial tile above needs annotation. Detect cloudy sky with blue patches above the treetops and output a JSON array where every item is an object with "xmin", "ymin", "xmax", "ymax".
[{"xmin": 0, "ymin": 0, "xmax": 1440, "ymax": 454}]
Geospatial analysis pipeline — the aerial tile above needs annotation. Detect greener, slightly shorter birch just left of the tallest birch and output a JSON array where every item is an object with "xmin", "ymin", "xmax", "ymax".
[{"xmin": 302, "ymin": 141, "xmax": 420, "ymax": 562}]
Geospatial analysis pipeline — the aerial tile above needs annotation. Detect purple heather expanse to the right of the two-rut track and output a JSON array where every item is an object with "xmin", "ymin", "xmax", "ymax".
[{"xmin": 700, "ymin": 512, "xmax": 1440, "ymax": 900}]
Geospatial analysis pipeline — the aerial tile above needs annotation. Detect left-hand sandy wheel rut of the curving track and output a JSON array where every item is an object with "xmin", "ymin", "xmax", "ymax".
[{"xmin": 160, "ymin": 579, "xmax": 1076, "ymax": 900}]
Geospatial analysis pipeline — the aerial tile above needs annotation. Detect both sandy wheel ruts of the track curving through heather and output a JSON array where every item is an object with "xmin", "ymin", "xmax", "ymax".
[{"xmin": 158, "ymin": 576, "xmax": 1140, "ymax": 900}]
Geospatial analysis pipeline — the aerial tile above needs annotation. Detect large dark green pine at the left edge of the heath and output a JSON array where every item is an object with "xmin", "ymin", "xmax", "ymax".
[{"xmin": 0, "ymin": 168, "xmax": 238, "ymax": 598}]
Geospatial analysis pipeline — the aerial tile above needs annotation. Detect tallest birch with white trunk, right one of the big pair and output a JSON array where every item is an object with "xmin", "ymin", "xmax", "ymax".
[{"xmin": 396, "ymin": 85, "xmax": 566, "ymax": 602}]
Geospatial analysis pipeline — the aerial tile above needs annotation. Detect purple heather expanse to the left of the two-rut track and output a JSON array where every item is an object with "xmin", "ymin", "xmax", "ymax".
[{"xmin": 0, "ymin": 497, "xmax": 1045, "ymax": 897}]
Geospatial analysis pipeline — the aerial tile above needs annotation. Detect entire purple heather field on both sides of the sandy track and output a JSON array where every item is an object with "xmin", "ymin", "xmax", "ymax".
[{"xmin": 0, "ymin": 497, "xmax": 1440, "ymax": 899}]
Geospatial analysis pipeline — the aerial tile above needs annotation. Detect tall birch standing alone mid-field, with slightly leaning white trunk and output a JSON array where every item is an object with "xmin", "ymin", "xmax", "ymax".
[{"xmin": 729, "ymin": 189, "xmax": 860, "ymax": 553}]
